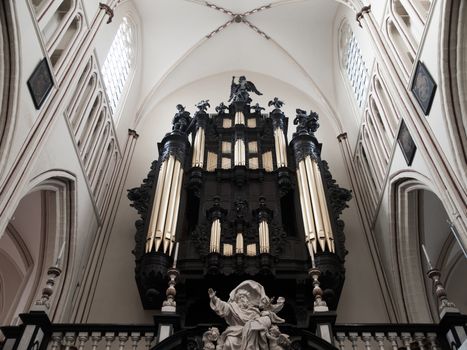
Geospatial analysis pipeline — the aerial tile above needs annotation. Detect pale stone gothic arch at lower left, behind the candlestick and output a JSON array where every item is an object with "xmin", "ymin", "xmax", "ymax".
[{"xmin": 0, "ymin": 170, "xmax": 75, "ymax": 323}]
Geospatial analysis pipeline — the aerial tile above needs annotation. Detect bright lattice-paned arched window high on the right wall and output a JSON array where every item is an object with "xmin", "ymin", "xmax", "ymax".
[{"xmin": 339, "ymin": 21, "xmax": 369, "ymax": 109}]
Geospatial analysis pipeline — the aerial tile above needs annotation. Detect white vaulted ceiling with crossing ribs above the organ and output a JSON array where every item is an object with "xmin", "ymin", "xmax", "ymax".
[{"xmin": 128, "ymin": 0, "xmax": 352, "ymax": 129}]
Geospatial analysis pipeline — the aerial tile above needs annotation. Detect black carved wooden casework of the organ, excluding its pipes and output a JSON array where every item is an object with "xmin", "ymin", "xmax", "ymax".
[{"xmin": 128, "ymin": 79, "xmax": 351, "ymax": 326}]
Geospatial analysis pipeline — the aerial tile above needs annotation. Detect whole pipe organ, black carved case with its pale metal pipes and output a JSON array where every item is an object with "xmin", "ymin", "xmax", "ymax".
[{"xmin": 128, "ymin": 88, "xmax": 351, "ymax": 326}]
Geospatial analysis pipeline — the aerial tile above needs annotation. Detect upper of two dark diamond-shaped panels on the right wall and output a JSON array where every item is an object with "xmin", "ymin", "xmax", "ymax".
[{"xmin": 411, "ymin": 61, "xmax": 436, "ymax": 115}]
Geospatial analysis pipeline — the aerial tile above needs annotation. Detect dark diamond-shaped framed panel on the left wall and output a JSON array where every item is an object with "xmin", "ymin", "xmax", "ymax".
[{"xmin": 28, "ymin": 58, "xmax": 54, "ymax": 109}]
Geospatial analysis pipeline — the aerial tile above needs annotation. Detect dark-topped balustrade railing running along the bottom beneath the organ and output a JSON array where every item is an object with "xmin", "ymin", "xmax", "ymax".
[{"xmin": 0, "ymin": 312, "xmax": 467, "ymax": 350}]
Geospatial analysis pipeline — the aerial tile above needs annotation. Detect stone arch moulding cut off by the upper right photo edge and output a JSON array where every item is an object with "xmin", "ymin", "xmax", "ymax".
[{"xmin": 440, "ymin": 0, "xmax": 467, "ymax": 183}]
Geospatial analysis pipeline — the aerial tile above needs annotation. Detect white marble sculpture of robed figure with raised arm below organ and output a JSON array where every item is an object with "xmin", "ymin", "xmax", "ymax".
[{"xmin": 208, "ymin": 280, "xmax": 290, "ymax": 350}]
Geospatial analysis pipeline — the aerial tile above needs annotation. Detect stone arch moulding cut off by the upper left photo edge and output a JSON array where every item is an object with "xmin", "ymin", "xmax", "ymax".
[{"xmin": 0, "ymin": 0, "xmax": 19, "ymax": 176}]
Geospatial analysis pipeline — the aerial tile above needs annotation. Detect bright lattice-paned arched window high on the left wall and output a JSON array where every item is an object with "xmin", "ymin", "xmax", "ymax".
[{"xmin": 102, "ymin": 17, "xmax": 135, "ymax": 118}]
